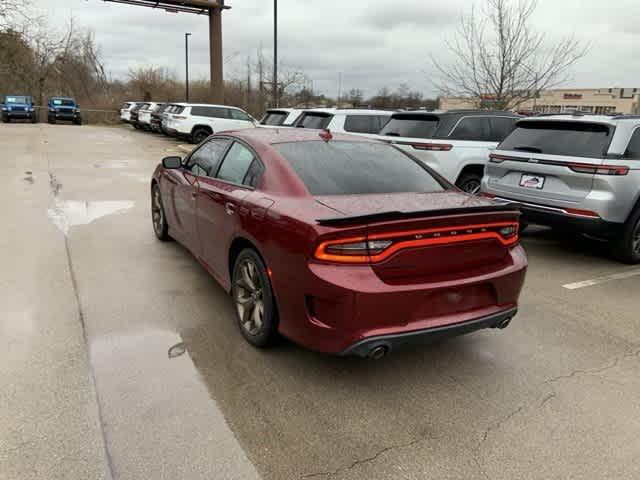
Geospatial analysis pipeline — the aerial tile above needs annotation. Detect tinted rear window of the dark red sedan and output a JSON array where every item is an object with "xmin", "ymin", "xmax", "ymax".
[{"xmin": 274, "ymin": 141, "xmax": 445, "ymax": 195}]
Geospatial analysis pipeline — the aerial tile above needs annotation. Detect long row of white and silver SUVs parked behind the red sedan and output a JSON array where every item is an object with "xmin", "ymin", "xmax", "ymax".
[{"xmin": 122, "ymin": 102, "xmax": 640, "ymax": 263}]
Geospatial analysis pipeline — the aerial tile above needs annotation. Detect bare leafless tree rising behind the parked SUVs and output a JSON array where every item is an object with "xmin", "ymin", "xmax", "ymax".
[{"xmin": 432, "ymin": 0, "xmax": 588, "ymax": 109}]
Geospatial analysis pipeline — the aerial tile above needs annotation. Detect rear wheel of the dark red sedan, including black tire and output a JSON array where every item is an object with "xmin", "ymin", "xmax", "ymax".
[{"xmin": 231, "ymin": 248, "xmax": 278, "ymax": 348}]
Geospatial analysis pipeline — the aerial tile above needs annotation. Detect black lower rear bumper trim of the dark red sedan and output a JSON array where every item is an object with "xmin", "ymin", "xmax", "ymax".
[{"xmin": 339, "ymin": 307, "xmax": 518, "ymax": 357}]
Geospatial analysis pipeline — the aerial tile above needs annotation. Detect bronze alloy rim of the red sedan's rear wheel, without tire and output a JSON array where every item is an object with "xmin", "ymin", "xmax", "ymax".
[{"xmin": 234, "ymin": 259, "xmax": 264, "ymax": 336}]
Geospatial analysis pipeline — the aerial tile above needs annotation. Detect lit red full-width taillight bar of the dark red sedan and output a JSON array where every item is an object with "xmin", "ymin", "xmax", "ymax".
[{"xmin": 314, "ymin": 222, "xmax": 519, "ymax": 264}]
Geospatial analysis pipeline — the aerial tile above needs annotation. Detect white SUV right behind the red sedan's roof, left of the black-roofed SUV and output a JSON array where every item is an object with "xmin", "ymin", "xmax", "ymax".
[{"xmin": 293, "ymin": 108, "xmax": 393, "ymax": 136}]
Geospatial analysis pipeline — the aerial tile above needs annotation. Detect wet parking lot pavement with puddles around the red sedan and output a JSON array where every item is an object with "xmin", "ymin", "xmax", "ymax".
[{"xmin": 0, "ymin": 124, "xmax": 640, "ymax": 480}]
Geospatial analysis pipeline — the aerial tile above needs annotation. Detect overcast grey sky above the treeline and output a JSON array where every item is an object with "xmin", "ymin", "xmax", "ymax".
[{"xmin": 40, "ymin": 0, "xmax": 640, "ymax": 96}]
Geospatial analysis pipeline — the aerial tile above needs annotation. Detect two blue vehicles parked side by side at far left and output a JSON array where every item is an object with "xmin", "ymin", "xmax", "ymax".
[{"xmin": 2, "ymin": 95, "xmax": 82, "ymax": 125}]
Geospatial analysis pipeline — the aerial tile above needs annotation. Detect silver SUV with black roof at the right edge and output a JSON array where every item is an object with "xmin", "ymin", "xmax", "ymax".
[{"xmin": 482, "ymin": 114, "xmax": 640, "ymax": 263}]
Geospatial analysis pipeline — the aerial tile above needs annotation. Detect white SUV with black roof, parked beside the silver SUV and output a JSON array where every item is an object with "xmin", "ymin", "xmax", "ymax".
[{"xmin": 378, "ymin": 110, "xmax": 521, "ymax": 194}]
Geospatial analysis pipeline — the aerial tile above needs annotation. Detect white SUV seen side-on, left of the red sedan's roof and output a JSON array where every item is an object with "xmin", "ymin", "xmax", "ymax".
[{"xmin": 165, "ymin": 103, "xmax": 256, "ymax": 143}]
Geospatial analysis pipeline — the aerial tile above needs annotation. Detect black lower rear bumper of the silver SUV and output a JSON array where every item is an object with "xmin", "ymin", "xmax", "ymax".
[{"xmin": 496, "ymin": 197, "xmax": 624, "ymax": 238}]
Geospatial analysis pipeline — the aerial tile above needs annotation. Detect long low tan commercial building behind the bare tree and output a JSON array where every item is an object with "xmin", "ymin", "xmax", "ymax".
[{"xmin": 440, "ymin": 88, "xmax": 640, "ymax": 114}]
